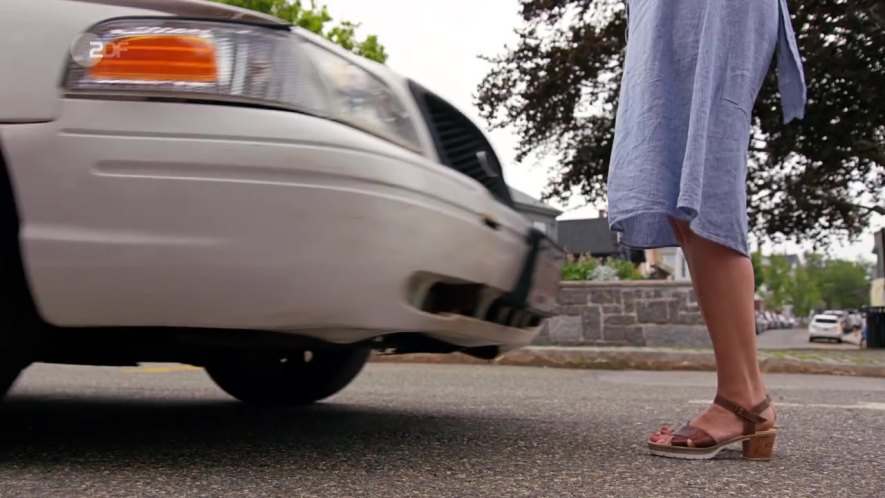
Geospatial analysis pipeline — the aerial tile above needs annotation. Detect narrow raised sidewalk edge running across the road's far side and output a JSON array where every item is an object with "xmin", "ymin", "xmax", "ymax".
[{"xmin": 373, "ymin": 346, "xmax": 885, "ymax": 378}]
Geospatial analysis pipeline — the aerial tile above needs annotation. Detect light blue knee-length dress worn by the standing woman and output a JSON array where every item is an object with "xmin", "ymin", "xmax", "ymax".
[{"xmin": 608, "ymin": 0, "xmax": 806, "ymax": 255}]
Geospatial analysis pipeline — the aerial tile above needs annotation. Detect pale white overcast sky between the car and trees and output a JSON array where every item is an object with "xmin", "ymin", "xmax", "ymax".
[{"xmin": 318, "ymin": 0, "xmax": 885, "ymax": 260}]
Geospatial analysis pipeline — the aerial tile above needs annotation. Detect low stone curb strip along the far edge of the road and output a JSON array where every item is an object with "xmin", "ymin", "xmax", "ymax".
[{"xmin": 372, "ymin": 347, "xmax": 885, "ymax": 378}]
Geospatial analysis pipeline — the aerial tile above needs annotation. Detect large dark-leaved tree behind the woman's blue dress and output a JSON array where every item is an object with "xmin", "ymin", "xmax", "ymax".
[{"xmin": 476, "ymin": 0, "xmax": 885, "ymax": 246}]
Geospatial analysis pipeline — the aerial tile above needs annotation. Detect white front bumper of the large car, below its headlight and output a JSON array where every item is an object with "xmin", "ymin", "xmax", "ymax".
[{"xmin": 0, "ymin": 99, "xmax": 552, "ymax": 348}]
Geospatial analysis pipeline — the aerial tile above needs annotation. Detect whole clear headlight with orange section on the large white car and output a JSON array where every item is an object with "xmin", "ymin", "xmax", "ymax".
[{"xmin": 65, "ymin": 19, "xmax": 420, "ymax": 150}]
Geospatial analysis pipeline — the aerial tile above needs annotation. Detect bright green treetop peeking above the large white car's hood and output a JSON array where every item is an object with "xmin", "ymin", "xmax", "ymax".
[{"xmin": 215, "ymin": 0, "xmax": 387, "ymax": 63}]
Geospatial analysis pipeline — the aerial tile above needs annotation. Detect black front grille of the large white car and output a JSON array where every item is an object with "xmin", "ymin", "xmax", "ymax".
[{"xmin": 411, "ymin": 82, "xmax": 513, "ymax": 207}]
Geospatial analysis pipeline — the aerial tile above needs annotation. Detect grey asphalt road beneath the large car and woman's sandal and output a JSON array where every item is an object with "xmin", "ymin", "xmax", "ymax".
[{"xmin": 0, "ymin": 364, "xmax": 885, "ymax": 498}]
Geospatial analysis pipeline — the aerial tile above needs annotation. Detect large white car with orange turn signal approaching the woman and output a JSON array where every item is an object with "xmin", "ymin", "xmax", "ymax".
[{"xmin": 0, "ymin": 0, "xmax": 563, "ymax": 404}]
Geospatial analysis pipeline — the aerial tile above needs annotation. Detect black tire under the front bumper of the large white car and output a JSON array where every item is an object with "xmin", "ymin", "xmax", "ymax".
[{"xmin": 205, "ymin": 347, "xmax": 370, "ymax": 406}]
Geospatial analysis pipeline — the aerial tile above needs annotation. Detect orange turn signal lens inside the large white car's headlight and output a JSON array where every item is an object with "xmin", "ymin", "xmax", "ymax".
[{"xmin": 88, "ymin": 35, "xmax": 218, "ymax": 83}]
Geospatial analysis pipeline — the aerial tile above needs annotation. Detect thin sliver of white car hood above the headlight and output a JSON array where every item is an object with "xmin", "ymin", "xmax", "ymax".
[{"xmin": 74, "ymin": 0, "xmax": 289, "ymax": 27}]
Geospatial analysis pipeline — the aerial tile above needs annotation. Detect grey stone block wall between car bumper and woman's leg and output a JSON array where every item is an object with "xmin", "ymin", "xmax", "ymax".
[{"xmin": 535, "ymin": 280, "xmax": 710, "ymax": 347}]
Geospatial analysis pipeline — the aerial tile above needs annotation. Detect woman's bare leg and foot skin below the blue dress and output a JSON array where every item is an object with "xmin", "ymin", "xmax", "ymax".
[{"xmin": 651, "ymin": 220, "xmax": 774, "ymax": 444}]
